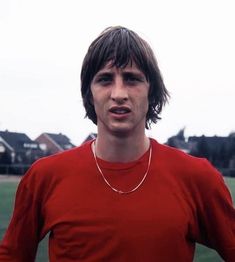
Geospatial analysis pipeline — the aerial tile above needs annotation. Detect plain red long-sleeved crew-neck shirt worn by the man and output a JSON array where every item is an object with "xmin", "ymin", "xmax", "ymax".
[{"xmin": 0, "ymin": 140, "xmax": 235, "ymax": 262}]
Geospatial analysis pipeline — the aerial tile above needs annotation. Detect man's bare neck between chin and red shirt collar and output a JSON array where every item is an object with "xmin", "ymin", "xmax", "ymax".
[{"xmin": 95, "ymin": 133, "xmax": 150, "ymax": 163}]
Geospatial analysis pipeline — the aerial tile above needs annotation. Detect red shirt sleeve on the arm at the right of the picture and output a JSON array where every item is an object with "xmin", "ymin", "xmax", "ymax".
[{"xmin": 197, "ymin": 161, "xmax": 235, "ymax": 262}]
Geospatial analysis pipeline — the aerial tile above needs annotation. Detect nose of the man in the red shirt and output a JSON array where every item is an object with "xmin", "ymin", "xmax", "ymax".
[{"xmin": 111, "ymin": 79, "xmax": 128, "ymax": 103}]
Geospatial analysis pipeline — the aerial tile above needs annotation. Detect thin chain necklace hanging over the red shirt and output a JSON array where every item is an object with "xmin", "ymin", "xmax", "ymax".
[{"xmin": 92, "ymin": 141, "xmax": 152, "ymax": 194}]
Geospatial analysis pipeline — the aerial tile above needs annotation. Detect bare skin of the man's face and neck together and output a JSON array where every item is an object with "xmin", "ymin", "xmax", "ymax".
[{"xmin": 91, "ymin": 63, "xmax": 150, "ymax": 162}]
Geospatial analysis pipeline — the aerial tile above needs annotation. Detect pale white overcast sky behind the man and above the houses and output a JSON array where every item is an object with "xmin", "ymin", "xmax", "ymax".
[{"xmin": 0, "ymin": 0, "xmax": 235, "ymax": 145}]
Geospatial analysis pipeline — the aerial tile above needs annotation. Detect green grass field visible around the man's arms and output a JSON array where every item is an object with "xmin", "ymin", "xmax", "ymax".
[{"xmin": 0, "ymin": 178, "xmax": 235, "ymax": 262}]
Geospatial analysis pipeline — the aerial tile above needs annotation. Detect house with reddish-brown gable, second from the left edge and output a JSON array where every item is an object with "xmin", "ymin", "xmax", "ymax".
[{"xmin": 35, "ymin": 133, "xmax": 75, "ymax": 155}]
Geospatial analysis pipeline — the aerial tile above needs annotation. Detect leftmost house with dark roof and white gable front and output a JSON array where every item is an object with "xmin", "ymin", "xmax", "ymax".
[{"xmin": 0, "ymin": 131, "xmax": 43, "ymax": 165}]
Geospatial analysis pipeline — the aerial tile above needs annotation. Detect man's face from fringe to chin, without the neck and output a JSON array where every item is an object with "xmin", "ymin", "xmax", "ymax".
[{"xmin": 91, "ymin": 63, "xmax": 149, "ymax": 135}]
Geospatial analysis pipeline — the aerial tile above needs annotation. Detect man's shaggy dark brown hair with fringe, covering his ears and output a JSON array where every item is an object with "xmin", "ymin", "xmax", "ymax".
[{"xmin": 81, "ymin": 26, "xmax": 169, "ymax": 129}]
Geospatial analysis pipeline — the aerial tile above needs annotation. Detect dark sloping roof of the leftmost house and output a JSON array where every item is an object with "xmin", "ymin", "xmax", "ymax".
[{"xmin": 0, "ymin": 131, "xmax": 38, "ymax": 151}]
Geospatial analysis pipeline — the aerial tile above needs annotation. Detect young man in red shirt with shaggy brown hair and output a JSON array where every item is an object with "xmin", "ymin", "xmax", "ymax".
[{"xmin": 0, "ymin": 27, "xmax": 235, "ymax": 262}]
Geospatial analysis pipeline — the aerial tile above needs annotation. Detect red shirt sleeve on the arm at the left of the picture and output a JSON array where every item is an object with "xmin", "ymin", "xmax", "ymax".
[{"xmin": 0, "ymin": 167, "xmax": 42, "ymax": 262}]
